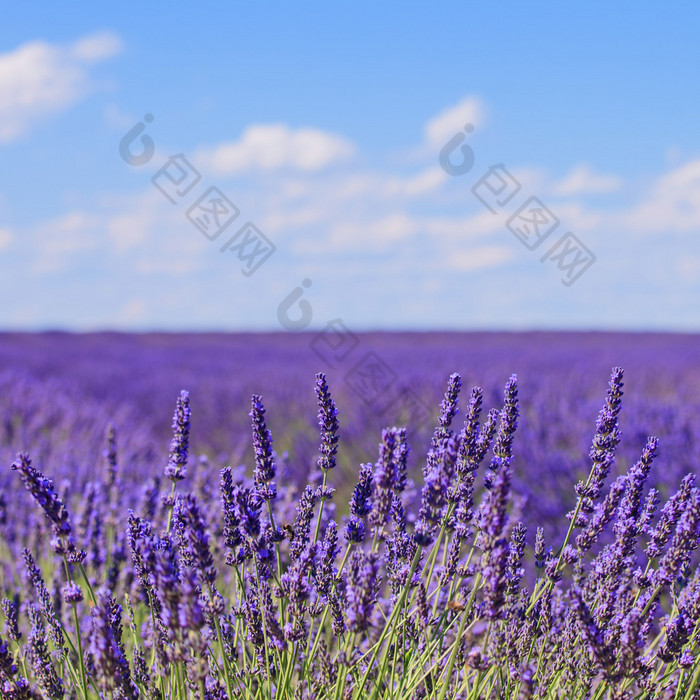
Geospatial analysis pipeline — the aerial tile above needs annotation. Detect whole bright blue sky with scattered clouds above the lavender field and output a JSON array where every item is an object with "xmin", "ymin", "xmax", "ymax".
[{"xmin": 0, "ymin": 2, "xmax": 700, "ymax": 331}]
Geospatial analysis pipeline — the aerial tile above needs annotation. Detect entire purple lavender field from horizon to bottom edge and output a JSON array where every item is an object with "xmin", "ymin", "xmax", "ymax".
[{"xmin": 0, "ymin": 333, "xmax": 700, "ymax": 700}]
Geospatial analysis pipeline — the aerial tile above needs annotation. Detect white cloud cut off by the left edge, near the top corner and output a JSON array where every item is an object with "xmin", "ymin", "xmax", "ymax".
[{"xmin": 0, "ymin": 32, "xmax": 122, "ymax": 142}]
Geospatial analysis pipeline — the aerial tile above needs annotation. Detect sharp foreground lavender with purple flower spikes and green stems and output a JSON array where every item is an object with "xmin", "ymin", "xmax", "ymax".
[{"xmin": 0, "ymin": 368, "xmax": 700, "ymax": 700}]
